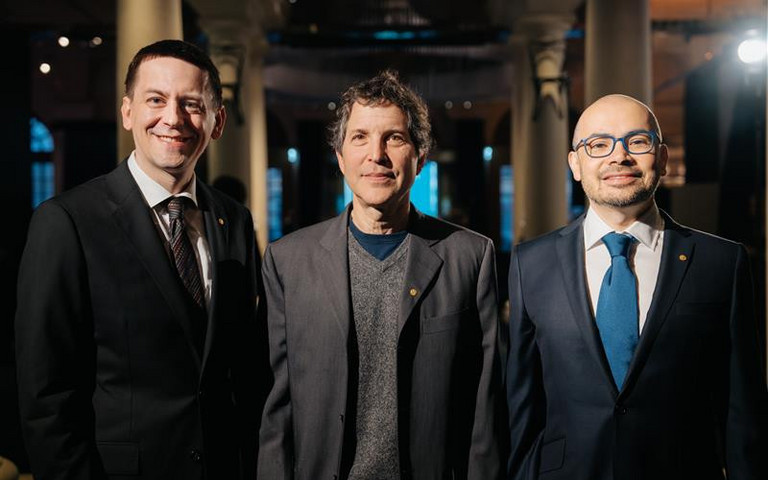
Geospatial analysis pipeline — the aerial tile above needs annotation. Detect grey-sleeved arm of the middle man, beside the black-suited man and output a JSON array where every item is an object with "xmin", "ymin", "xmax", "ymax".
[{"xmin": 258, "ymin": 246, "xmax": 293, "ymax": 480}]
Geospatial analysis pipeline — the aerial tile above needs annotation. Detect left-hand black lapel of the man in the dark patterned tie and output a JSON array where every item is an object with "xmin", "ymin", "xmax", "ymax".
[{"xmin": 106, "ymin": 161, "xmax": 201, "ymax": 367}]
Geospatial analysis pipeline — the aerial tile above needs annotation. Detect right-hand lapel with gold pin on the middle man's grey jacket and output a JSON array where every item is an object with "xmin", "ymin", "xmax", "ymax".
[{"xmin": 398, "ymin": 205, "xmax": 443, "ymax": 335}]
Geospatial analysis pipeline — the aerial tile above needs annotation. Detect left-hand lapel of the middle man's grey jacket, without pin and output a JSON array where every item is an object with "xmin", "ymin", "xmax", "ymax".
[{"xmin": 320, "ymin": 207, "xmax": 351, "ymax": 338}]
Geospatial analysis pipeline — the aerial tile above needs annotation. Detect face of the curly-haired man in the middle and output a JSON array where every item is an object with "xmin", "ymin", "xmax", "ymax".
[{"xmin": 336, "ymin": 103, "xmax": 424, "ymax": 217}]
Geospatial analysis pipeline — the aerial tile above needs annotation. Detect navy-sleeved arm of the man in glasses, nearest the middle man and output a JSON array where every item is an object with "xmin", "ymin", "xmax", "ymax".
[{"xmin": 507, "ymin": 250, "xmax": 546, "ymax": 480}]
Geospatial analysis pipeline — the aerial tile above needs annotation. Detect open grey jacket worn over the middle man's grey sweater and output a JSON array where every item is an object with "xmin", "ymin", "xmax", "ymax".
[{"xmin": 259, "ymin": 207, "xmax": 502, "ymax": 480}]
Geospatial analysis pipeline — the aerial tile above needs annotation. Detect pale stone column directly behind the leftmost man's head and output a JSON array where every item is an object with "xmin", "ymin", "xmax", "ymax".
[{"xmin": 116, "ymin": 0, "xmax": 183, "ymax": 162}]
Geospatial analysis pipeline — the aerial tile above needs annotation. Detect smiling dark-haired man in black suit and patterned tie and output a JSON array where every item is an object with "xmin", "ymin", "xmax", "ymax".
[{"xmin": 16, "ymin": 40, "xmax": 268, "ymax": 480}]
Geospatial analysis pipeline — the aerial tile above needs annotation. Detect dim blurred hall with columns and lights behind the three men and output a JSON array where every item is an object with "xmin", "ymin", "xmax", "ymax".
[{"xmin": 0, "ymin": 0, "xmax": 767, "ymax": 472}]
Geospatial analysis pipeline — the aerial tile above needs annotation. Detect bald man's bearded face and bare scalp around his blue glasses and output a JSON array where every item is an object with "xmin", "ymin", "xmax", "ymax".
[{"xmin": 568, "ymin": 95, "xmax": 667, "ymax": 216}]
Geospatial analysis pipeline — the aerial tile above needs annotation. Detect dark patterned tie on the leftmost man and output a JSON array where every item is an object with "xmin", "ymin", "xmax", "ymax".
[{"xmin": 168, "ymin": 197, "xmax": 205, "ymax": 308}]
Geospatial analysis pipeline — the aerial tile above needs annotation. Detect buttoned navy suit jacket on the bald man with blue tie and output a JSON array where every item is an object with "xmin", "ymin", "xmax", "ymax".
[{"xmin": 507, "ymin": 215, "xmax": 768, "ymax": 480}]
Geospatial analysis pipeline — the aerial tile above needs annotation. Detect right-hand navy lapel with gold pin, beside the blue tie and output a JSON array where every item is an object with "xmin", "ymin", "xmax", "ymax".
[{"xmin": 622, "ymin": 212, "xmax": 695, "ymax": 396}]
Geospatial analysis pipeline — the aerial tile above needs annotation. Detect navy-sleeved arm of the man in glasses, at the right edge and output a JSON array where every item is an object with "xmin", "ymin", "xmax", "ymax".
[{"xmin": 725, "ymin": 247, "xmax": 768, "ymax": 480}]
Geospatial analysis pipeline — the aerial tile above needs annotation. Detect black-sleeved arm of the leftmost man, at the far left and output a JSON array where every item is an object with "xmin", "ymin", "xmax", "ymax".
[{"xmin": 16, "ymin": 202, "xmax": 104, "ymax": 480}]
